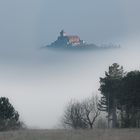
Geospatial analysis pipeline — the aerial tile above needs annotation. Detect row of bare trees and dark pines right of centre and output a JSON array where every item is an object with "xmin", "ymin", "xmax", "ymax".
[{"xmin": 62, "ymin": 63, "xmax": 140, "ymax": 128}]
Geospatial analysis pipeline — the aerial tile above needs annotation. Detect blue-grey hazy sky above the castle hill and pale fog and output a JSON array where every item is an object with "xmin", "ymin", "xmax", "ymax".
[{"xmin": 0, "ymin": 0, "xmax": 140, "ymax": 51}]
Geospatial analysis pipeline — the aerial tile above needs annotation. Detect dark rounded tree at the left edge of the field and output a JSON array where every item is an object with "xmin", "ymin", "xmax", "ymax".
[{"xmin": 0, "ymin": 97, "xmax": 21, "ymax": 131}]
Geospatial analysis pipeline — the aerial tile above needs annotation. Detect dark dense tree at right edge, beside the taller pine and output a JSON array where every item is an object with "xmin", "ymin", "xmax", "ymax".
[{"xmin": 120, "ymin": 71, "xmax": 140, "ymax": 128}]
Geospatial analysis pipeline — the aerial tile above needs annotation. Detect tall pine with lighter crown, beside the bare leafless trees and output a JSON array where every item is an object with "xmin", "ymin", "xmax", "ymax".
[{"xmin": 99, "ymin": 63, "xmax": 125, "ymax": 128}]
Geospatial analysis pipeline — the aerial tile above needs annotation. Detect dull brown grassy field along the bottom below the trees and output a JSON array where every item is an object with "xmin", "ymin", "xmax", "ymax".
[{"xmin": 0, "ymin": 129, "xmax": 140, "ymax": 140}]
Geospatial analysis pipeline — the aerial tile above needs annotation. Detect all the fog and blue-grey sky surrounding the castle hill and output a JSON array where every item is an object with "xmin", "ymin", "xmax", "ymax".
[{"xmin": 0, "ymin": 0, "xmax": 140, "ymax": 128}]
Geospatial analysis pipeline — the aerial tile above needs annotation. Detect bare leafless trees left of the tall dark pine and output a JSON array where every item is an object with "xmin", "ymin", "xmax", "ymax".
[{"xmin": 62, "ymin": 96, "xmax": 100, "ymax": 129}]
